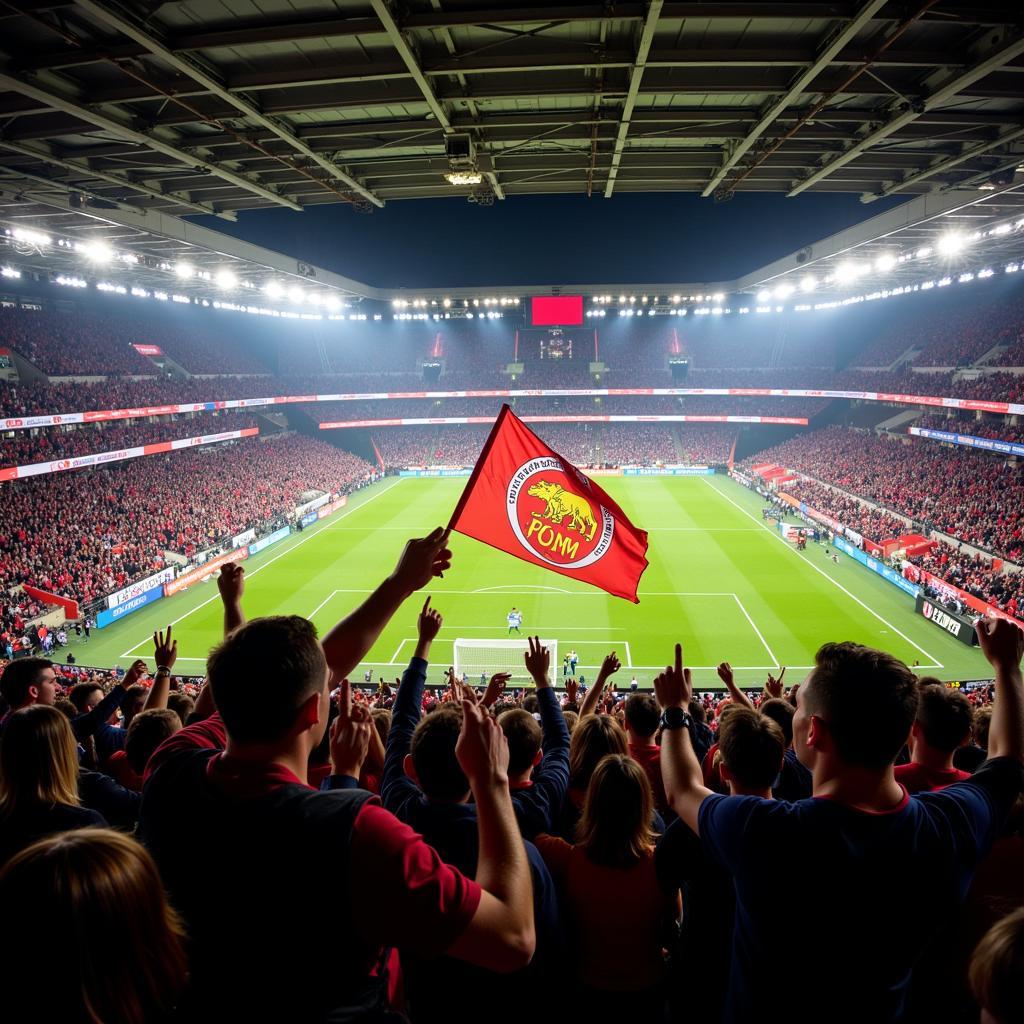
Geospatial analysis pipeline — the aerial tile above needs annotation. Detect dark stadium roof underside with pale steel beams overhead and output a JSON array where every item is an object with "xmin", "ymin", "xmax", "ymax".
[{"xmin": 0, "ymin": 0, "xmax": 1024, "ymax": 217}]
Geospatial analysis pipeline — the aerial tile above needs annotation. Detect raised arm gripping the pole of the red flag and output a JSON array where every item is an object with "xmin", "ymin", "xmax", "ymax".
[{"xmin": 324, "ymin": 526, "xmax": 452, "ymax": 679}]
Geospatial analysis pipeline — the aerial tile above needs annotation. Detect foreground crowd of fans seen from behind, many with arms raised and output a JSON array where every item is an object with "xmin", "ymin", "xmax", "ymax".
[{"xmin": 0, "ymin": 527, "xmax": 1024, "ymax": 1024}]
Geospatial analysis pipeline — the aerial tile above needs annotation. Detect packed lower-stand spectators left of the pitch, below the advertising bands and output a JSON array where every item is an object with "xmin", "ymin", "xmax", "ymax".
[{"xmin": 0, "ymin": 435, "xmax": 373, "ymax": 603}]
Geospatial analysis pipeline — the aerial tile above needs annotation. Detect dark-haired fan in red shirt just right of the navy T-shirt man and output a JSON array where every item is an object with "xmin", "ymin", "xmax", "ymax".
[{"xmin": 896, "ymin": 679, "xmax": 974, "ymax": 793}]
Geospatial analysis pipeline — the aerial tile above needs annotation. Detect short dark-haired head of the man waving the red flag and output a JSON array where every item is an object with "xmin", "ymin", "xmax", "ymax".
[{"xmin": 207, "ymin": 615, "xmax": 327, "ymax": 743}]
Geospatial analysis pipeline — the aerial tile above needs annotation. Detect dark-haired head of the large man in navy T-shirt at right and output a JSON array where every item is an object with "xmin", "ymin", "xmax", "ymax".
[{"xmin": 800, "ymin": 641, "xmax": 918, "ymax": 771}]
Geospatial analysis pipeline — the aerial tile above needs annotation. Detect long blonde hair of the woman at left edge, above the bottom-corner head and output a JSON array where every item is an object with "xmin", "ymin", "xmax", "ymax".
[{"xmin": 0, "ymin": 705, "xmax": 78, "ymax": 817}]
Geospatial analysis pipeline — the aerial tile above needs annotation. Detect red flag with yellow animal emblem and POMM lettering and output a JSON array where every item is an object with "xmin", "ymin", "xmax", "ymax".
[{"xmin": 449, "ymin": 406, "xmax": 647, "ymax": 603}]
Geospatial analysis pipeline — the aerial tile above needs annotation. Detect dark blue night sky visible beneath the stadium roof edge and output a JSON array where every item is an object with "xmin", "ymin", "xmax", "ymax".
[{"xmin": 195, "ymin": 193, "xmax": 906, "ymax": 288}]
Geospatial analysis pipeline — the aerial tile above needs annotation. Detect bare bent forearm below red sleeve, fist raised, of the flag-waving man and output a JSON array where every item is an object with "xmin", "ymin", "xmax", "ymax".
[{"xmin": 449, "ymin": 698, "xmax": 537, "ymax": 972}]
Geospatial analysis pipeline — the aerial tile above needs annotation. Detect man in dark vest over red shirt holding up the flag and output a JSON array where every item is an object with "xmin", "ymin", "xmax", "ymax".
[{"xmin": 139, "ymin": 529, "xmax": 535, "ymax": 1024}]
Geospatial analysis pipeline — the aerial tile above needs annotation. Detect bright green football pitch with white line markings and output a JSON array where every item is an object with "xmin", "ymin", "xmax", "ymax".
[{"xmin": 72, "ymin": 476, "xmax": 989, "ymax": 688}]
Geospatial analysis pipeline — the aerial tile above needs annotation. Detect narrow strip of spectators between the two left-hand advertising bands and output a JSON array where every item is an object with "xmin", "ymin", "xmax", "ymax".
[{"xmin": 0, "ymin": 412, "xmax": 257, "ymax": 467}]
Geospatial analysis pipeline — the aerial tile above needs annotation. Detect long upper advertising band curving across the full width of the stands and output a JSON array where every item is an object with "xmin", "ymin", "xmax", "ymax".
[{"xmin": 0, "ymin": 387, "xmax": 1024, "ymax": 439}]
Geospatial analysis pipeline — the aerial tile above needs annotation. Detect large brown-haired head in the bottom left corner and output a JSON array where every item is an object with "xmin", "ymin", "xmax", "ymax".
[{"xmin": 0, "ymin": 828, "xmax": 187, "ymax": 1024}]
